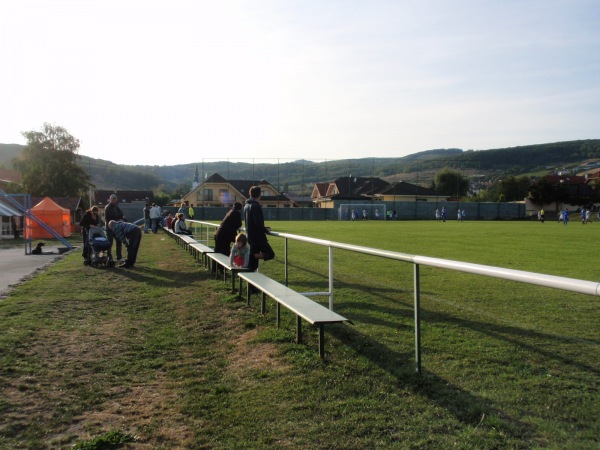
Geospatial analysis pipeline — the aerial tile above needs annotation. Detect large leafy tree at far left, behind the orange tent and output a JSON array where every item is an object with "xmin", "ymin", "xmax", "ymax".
[{"xmin": 13, "ymin": 123, "xmax": 90, "ymax": 197}]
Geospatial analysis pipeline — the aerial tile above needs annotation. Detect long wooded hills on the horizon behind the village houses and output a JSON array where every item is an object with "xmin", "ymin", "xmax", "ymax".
[{"xmin": 0, "ymin": 139, "xmax": 600, "ymax": 195}]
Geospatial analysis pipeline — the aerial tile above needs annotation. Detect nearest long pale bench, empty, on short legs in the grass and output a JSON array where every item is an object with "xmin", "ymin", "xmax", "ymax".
[{"xmin": 238, "ymin": 272, "xmax": 348, "ymax": 358}]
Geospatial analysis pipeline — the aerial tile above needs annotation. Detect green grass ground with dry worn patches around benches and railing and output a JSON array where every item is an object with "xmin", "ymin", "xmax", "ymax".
[{"xmin": 0, "ymin": 221, "xmax": 600, "ymax": 449}]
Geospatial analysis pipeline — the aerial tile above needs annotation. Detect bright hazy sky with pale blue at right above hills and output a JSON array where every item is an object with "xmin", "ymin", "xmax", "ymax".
[{"xmin": 0, "ymin": 0, "xmax": 600, "ymax": 165}]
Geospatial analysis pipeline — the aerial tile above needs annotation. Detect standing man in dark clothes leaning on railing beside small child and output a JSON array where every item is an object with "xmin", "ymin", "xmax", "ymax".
[{"xmin": 244, "ymin": 186, "xmax": 275, "ymax": 272}]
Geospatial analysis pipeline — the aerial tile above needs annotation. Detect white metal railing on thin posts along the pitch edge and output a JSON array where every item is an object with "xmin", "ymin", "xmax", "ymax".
[{"xmin": 189, "ymin": 222, "xmax": 600, "ymax": 373}]
